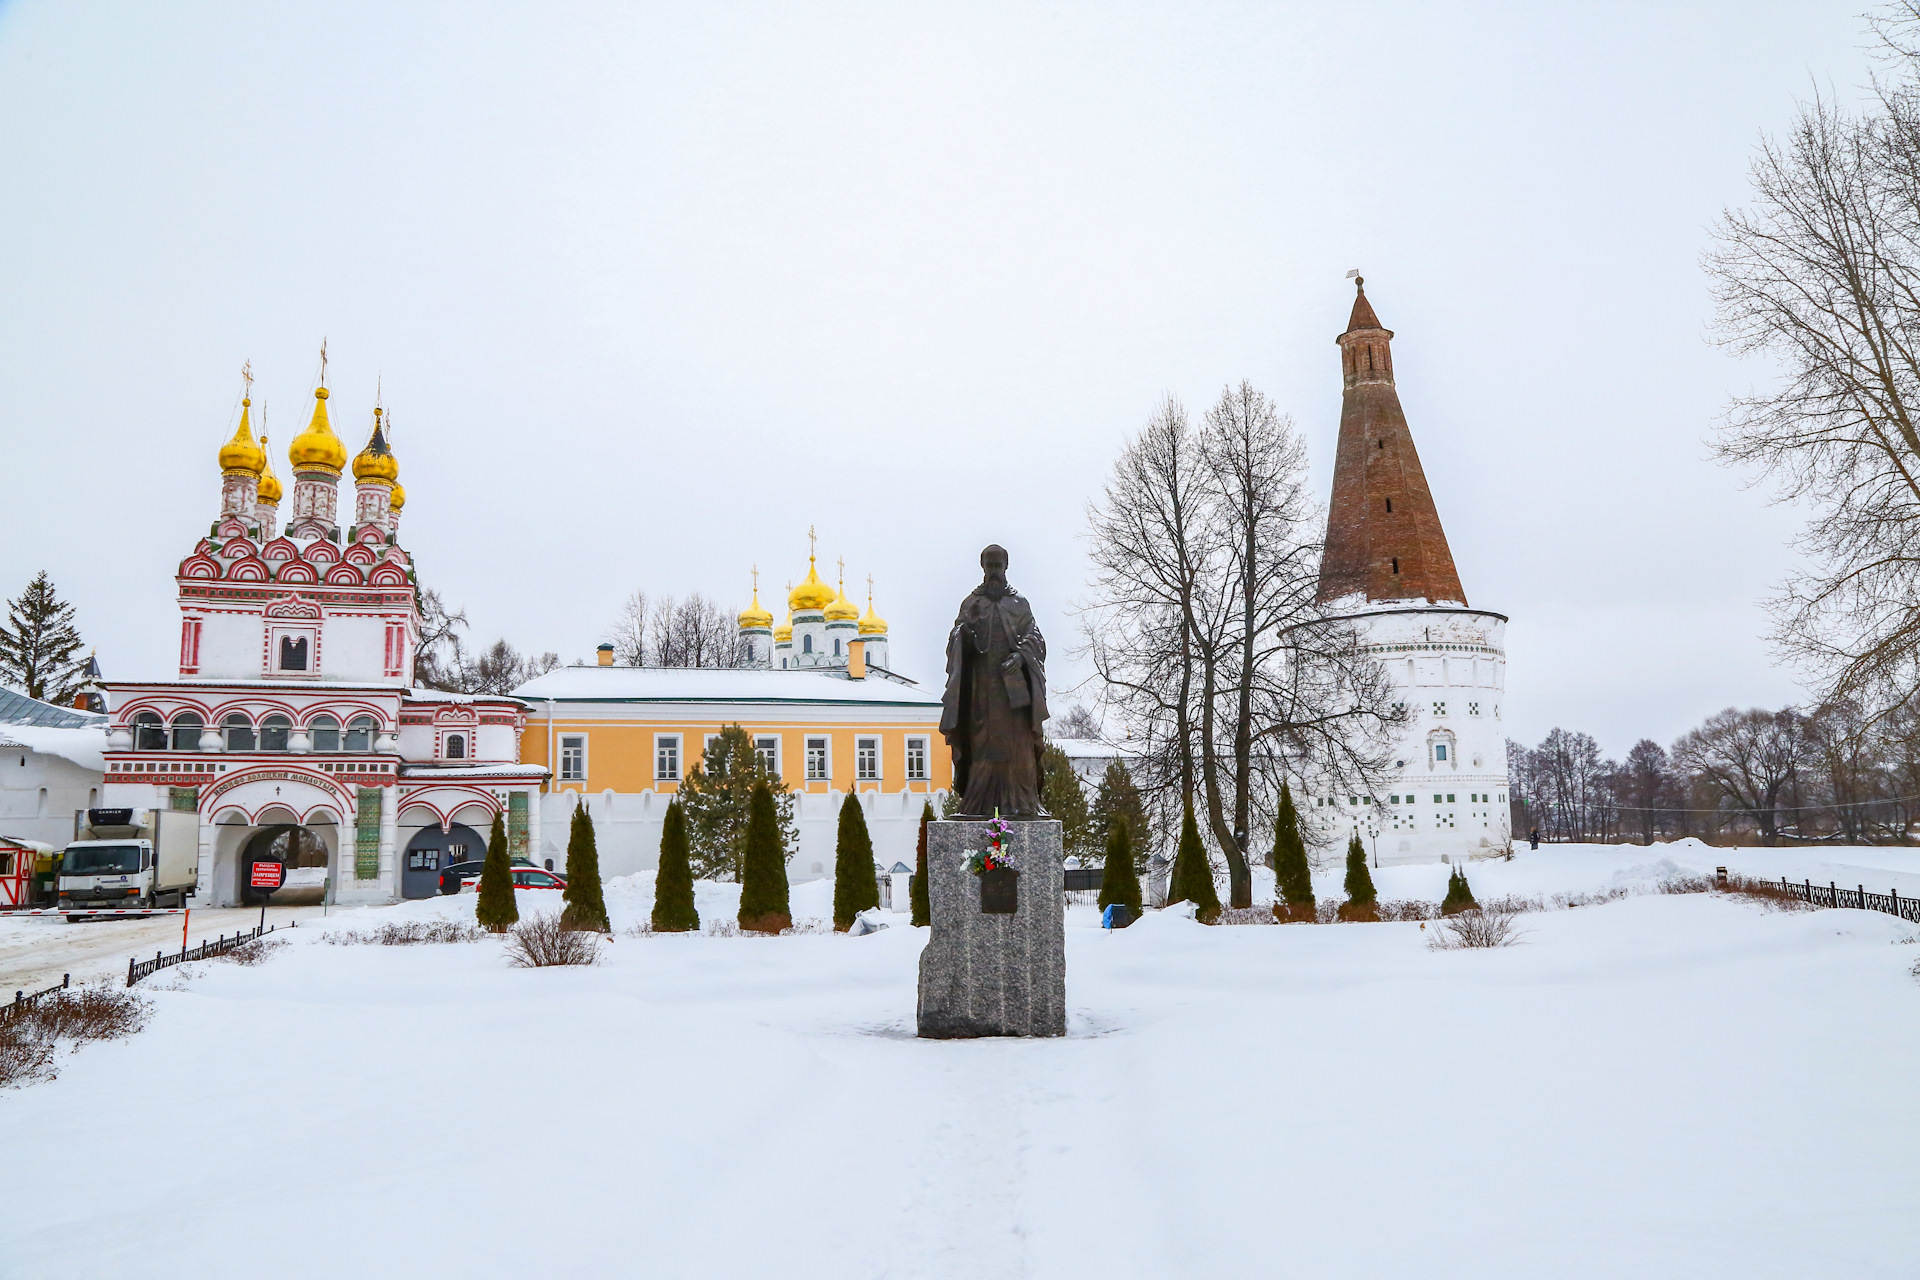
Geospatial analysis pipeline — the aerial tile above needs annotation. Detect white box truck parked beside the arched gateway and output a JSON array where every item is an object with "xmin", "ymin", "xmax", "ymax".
[{"xmin": 60, "ymin": 810, "xmax": 200, "ymax": 919}]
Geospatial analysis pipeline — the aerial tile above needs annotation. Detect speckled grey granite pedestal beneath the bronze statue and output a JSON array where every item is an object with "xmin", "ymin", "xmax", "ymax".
[{"xmin": 920, "ymin": 819, "xmax": 1068, "ymax": 1040}]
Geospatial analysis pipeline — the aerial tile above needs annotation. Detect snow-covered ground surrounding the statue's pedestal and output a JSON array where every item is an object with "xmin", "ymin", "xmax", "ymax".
[{"xmin": 0, "ymin": 844, "xmax": 1920, "ymax": 1280}]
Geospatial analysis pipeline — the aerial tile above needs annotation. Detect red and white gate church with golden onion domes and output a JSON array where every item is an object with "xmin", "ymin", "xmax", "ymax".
[{"xmin": 102, "ymin": 376, "xmax": 547, "ymax": 906}]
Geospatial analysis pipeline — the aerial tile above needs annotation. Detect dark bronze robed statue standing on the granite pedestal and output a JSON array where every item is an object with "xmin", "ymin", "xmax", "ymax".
[{"xmin": 941, "ymin": 547, "xmax": 1046, "ymax": 818}]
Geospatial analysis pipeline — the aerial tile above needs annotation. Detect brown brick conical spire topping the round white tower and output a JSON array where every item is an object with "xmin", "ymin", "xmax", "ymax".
[{"xmin": 1319, "ymin": 280, "xmax": 1467, "ymax": 604}]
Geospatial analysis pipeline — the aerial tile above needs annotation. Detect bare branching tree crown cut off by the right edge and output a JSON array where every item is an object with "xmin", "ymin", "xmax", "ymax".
[{"xmin": 1705, "ymin": 29, "xmax": 1920, "ymax": 708}]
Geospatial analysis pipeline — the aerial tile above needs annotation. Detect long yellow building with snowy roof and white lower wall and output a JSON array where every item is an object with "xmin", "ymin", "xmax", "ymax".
[{"xmin": 515, "ymin": 660, "xmax": 952, "ymax": 883}]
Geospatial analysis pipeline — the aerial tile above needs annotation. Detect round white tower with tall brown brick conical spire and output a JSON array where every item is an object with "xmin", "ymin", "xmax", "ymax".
[{"xmin": 1313, "ymin": 280, "xmax": 1511, "ymax": 865}]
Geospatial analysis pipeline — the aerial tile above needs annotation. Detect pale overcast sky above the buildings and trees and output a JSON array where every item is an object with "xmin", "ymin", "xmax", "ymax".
[{"xmin": 0, "ymin": 0, "xmax": 1870, "ymax": 754}]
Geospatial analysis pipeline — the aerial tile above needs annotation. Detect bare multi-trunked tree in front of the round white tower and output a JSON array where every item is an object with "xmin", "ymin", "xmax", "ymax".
[{"xmin": 1083, "ymin": 382, "xmax": 1396, "ymax": 906}]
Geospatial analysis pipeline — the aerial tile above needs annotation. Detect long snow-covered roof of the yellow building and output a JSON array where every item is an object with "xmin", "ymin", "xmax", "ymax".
[{"xmin": 513, "ymin": 666, "xmax": 941, "ymax": 706}]
